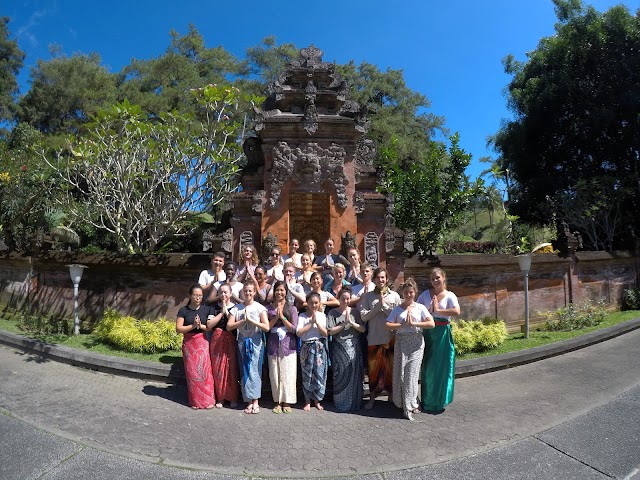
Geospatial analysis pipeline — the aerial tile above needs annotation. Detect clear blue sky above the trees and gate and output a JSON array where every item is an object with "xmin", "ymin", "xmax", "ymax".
[{"xmin": 6, "ymin": 0, "xmax": 640, "ymax": 178}]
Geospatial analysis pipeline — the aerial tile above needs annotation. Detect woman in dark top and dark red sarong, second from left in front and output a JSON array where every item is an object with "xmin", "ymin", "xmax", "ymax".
[{"xmin": 207, "ymin": 283, "xmax": 239, "ymax": 408}]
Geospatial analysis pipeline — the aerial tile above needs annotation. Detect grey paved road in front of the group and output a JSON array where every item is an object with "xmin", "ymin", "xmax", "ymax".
[{"xmin": 0, "ymin": 330, "xmax": 640, "ymax": 480}]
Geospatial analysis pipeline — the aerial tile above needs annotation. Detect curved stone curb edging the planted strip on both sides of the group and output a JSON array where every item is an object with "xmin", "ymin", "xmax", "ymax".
[{"xmin": 0, "ymin": 318, "xmax": 640, "ymax": 383}]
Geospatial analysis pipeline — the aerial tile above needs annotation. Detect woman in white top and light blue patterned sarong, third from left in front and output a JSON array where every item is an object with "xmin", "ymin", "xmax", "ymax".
[{"xmin": 227, "ymin": 281, "xmax": 269, "ymax": 413}]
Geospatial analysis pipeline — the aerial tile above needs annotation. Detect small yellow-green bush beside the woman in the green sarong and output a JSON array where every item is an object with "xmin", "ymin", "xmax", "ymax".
[{"xmin": 451, "ymin": 320, "xmax": 507, "ymax": 355}]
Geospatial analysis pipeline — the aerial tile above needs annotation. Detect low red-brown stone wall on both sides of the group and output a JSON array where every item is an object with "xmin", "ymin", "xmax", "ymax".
[{"xmin": 0, "ymin": 252, "xmax": 639, "ymax": 329}]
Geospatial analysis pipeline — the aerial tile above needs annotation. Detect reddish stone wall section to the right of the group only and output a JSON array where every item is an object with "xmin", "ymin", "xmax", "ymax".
[{"xmin": 404, "ymin": 252, "xmax": 640, "ymax": 328}]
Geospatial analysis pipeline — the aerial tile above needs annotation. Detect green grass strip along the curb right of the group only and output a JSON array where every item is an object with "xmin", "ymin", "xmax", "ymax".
[{"xmin": 458, "ymin": 310, "xmax": 640, "ymax": 360}]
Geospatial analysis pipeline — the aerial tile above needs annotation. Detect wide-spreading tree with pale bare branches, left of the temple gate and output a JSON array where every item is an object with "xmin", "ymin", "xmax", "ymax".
[{"xmin": 41, "ymin": 85, "xmax": 255, "ymax": 253}]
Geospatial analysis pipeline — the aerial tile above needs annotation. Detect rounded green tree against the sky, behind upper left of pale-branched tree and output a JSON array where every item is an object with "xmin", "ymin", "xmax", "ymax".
[{"xmin": 19, "ymin": 53, "xmax": 116, "ymax": 134}]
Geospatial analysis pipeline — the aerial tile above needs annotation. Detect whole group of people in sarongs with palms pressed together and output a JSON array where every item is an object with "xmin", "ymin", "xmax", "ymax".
[{"xmin": 176, "ymin": 239, "xmax": 460, "ymax": 420}]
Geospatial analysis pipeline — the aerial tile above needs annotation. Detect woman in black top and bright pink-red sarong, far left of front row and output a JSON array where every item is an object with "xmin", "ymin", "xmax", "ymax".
[{"xmin": 176, "ymin": 285, "xmax": 215, "ymax": 410}]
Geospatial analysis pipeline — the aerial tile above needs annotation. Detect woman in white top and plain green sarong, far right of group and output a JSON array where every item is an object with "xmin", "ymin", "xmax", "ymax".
[{"xmin": 418, "ymin": 268, "xmax": 460, "ymax": 413}]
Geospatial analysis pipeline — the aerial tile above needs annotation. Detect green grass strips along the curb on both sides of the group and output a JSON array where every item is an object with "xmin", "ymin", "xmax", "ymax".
[{"xmin": 0, "ymin": 309, "xmax": 640, "ymax": 364}]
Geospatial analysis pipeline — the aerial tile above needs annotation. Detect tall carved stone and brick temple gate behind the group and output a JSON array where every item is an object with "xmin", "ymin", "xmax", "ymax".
[{"xmin": 231, "ymin": 46, "xmax": 395, "ymax": 265}]
